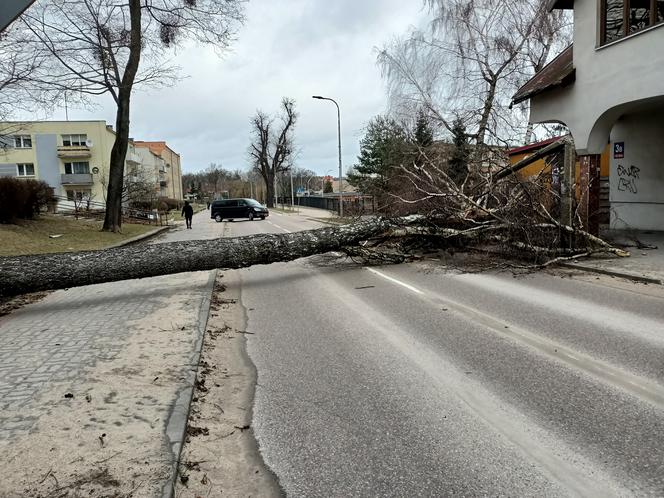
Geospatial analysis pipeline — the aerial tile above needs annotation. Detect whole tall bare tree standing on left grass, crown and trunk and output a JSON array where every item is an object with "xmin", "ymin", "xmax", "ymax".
[{"xmin": 14, "ymin": 0, "xmax": 244, "ymax": 231}]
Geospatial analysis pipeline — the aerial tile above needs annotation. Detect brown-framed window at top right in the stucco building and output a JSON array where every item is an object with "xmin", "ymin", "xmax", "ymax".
[{"xmin": 601, "ymin": 0, "xmax": 664, "ymax": 45}]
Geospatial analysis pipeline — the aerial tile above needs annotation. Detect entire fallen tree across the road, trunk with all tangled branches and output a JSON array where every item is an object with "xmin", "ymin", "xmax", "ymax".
[{"xmin": 0, "ymin": 140, "xmax": 629, "ymax": 298}]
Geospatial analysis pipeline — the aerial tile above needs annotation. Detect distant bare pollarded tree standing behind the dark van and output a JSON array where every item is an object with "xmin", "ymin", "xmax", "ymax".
[{"xmin": 249, "ymin": 97, "xmax": 298, "ymax": 207}]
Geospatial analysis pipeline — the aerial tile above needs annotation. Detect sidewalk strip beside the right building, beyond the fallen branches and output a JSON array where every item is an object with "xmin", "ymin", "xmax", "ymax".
[{"xmin": 566, "ymin": 231, "xmax": 664, "ymax": 285}]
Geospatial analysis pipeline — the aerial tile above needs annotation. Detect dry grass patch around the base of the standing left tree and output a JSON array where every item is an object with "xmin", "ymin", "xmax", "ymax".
[{"xmin": 0, "ymin": 215, "xmax": 155, "ymax": 256}]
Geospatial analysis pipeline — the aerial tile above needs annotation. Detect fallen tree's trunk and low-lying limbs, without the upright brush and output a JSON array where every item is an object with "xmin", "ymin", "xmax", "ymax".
[{"xmin": 0, "ymin": 208, "xmax": 625, "ymax": 298}]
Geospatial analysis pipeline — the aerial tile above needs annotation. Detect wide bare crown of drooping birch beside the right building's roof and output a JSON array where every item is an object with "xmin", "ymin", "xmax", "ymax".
[{"xmin": 378, "ymin": 0, "xmax": 569, "ymax": 145}]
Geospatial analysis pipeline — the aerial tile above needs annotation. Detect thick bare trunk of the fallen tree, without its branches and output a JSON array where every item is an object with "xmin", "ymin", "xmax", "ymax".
[{"xmin": 0, "ymin": 216, "xmax": 400, "ymax": 297}]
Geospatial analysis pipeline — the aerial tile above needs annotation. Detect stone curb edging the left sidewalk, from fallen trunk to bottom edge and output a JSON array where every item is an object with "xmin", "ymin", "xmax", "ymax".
[{"xmin": 161, "ymin": 270, "xmax": 217, "ymax": 498}]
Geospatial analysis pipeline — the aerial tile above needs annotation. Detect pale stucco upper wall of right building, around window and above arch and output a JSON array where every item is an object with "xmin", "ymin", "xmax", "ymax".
[{"xmin": 530, "ymin": 0, "xmax": 664, "ymax": 154}]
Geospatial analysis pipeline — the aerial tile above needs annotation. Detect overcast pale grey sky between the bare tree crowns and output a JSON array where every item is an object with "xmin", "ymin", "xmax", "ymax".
[{"xmin": 49, "ymin": 0, "xmax": 424, "ymax": 174}]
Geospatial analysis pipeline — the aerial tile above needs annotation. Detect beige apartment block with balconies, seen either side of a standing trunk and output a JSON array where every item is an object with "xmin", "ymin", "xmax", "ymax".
[{"xmin": 0, "ymin": 121, "xmax": 182, "ymax": 210}]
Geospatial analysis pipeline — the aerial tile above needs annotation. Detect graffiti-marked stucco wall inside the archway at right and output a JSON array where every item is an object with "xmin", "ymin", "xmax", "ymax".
[{"xmin": 609, "ymin": 108, "xmax": 664, "ymax": 230}]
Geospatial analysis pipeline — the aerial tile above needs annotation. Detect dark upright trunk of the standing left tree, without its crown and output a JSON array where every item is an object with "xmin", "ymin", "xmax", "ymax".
[{"xmin": 102, "ymin": 0, "xmax": 141, "ymax": 232}]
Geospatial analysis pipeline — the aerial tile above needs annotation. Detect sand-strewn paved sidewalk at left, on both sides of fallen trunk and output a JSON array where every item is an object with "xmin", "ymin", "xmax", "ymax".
[{"xmin": 0, "ymin": 208, "xmax": 215, "ymax": 497}]
